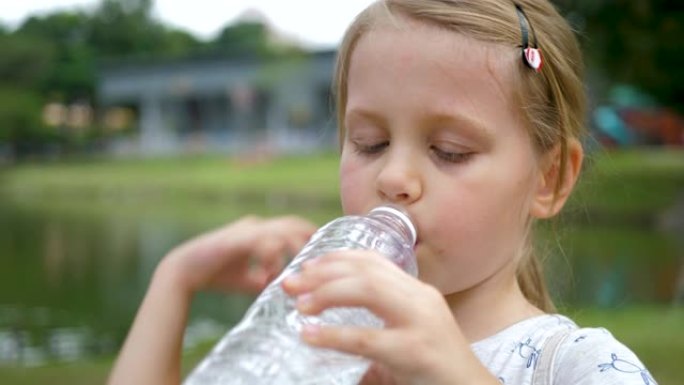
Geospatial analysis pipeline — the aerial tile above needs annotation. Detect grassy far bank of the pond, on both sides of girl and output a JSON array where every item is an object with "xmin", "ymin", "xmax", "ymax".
[{"xmin": 0, "ymin": 149, "xmax": 684, "ymax": 219}]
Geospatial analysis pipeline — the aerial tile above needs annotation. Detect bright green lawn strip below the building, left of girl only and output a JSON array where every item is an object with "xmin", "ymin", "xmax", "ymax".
[{"xmin": 0, "ymin": 154, "xmax": 338, "ymax": 207}]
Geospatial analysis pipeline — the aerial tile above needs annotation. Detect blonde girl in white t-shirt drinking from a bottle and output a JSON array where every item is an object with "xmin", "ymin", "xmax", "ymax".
[{"xmin": 110, "ymin": 0, "xmax": 655, "ymax": 385}]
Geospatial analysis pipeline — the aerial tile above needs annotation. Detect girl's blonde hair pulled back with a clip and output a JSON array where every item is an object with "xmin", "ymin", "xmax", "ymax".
[{"xmin": 334, "ymin": 0, "xmax": 585, "ymax": 312}]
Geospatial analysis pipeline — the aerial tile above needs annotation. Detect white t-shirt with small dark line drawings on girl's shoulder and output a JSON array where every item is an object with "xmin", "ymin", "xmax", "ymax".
[{"xmin": 471, "ymin": 314, "xmax": 656, "ymax": 385}]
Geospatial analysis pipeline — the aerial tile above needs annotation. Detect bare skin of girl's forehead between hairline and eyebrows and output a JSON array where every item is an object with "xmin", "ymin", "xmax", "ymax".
[{"xmin": 347, "ymin": 20, "xmax": 519, "ymax": 103}]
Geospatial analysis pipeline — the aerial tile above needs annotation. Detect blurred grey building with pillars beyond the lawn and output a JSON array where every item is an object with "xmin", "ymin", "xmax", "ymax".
[{"xmin": 97, "ymin": 51, "xmax": 336, "ymax": 154}]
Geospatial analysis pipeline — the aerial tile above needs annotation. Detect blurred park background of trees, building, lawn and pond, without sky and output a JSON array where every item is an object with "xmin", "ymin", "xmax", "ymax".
[{"xmin": 0, "ymin": 0, "xmax": 684, "ymax": 385}]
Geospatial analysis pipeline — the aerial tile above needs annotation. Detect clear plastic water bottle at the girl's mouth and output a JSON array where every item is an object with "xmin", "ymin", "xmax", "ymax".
[{"xmin": 184, "ymin": 206, "xmax": 418, "ymax": 385}]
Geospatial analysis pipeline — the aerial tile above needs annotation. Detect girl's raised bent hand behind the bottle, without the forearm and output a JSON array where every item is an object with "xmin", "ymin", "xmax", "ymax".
[{"xmin": 161, "ymin": 216, "xmax": 316, "ymax": 294}]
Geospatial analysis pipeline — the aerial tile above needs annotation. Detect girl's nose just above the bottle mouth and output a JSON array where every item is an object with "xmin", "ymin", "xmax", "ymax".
[{"xmin": 376, "ymin": 157, "xmax": 423, "ymax": 204}]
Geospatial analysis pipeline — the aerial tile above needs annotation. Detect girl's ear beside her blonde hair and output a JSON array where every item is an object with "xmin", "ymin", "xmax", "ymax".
[{"xmin": 530, "ymin": 139, "xmax": 584, "ymax": 218}]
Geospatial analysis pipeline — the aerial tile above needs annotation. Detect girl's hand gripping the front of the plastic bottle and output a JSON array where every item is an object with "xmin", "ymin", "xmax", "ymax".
[{"xmin": 283, "ymin": 250, "xmax": 498, "ymax": 385}]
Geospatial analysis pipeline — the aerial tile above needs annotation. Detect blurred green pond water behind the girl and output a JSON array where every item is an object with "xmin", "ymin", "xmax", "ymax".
[{"xmin": 0, "ymin": 198, "xmax": 684, "ymax": 366}]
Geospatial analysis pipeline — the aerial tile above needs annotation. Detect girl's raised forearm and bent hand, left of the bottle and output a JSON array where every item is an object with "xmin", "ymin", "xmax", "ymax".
[{"xmin": 108, "ymin": 217, "xmax": 316, "ymax": 385}]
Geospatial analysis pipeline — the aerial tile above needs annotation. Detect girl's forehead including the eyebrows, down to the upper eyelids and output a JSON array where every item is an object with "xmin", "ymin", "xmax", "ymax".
[{"xmin": 344, "ymin": 19, "xmax": 521, "ymax": 139}]
